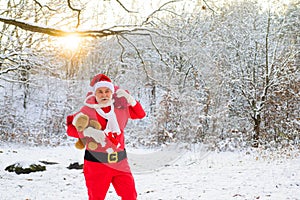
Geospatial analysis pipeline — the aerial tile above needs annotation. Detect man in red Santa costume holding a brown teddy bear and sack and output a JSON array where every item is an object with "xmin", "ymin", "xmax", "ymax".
[{"xmin": 67, "ymin": 74, "xmax": 145, "ymax": 200}]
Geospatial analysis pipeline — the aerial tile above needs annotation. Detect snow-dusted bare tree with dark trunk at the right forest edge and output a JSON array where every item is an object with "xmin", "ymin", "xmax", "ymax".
[{"xmin": 212, "ymin": 0, "xmax": 297, "ymax": 147}]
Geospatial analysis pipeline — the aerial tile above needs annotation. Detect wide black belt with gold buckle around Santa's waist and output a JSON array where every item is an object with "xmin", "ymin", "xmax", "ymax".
[{"xmin": 84, "ymin": 149, "xmax": 127, "ymax": 163}]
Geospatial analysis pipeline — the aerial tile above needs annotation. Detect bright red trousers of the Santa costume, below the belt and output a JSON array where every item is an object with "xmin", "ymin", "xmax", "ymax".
[{"xmin": 83, "ymin": 159, "xmax": 137, "ymax": 200}]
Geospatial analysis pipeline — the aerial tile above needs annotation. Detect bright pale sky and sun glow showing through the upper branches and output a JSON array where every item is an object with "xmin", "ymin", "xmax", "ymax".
[{"xmin": 48, "ymin": 0, "xmax": 295, "ymax": 50}]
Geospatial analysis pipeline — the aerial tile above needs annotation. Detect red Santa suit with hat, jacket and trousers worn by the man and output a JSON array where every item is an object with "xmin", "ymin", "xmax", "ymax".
[{"xmin": 67, "ymin": 74, "xmax": 145, "ymax": 200}]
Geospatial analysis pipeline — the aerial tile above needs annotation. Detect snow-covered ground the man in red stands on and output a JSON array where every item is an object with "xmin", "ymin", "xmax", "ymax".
[{"xmin": 0, "ymin": 144, "xmax": 300, "ymax": 200}]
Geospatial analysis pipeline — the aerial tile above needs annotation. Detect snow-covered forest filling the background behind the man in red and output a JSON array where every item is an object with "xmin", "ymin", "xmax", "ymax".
[{"xmin": 0, "ymin": 0, "xmax": 300, "ymax": 151}]
